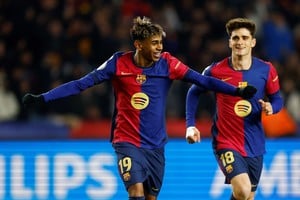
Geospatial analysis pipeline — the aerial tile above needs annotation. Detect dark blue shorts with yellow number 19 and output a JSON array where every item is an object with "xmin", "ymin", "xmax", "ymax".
[{"xmin": 113, "ymin": 143, "xmax": 165, "ymax": 196}]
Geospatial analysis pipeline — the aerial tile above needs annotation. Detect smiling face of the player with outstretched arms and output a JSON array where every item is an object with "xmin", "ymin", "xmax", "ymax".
[{"xmin": 135, "ymin": 35, "xmax": 163, "ymax": 67}]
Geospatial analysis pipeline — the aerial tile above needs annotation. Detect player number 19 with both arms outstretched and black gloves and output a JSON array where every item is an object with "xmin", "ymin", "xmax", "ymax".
[{"xmin": 23, "ymin": 17, "xmax": 256, "ymax": 200}]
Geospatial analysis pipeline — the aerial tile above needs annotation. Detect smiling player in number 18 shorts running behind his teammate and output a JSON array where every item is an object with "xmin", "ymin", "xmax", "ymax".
[{"xmin": 186, "ymin": 18, "xmax": 283, "ymax": 200}]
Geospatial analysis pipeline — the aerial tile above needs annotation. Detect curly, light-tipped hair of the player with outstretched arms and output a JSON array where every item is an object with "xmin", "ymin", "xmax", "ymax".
[{"xmin": 130, "ymin": 17, "xmax": 166, "ymax": 41}]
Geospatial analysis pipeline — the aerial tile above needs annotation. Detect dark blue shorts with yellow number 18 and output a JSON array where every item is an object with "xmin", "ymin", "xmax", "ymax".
[{"xmin": 215, "ymin": 149, "xmax": 263, "ymax": 192}]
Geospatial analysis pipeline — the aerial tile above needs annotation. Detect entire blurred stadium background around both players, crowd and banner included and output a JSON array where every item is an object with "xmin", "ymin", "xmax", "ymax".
[{"xmin": 0, "ymin": 0, "xmax": 300, "ymax": 199}]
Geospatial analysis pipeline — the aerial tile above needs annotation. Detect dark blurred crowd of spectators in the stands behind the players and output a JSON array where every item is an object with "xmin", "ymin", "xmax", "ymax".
[{"xmin": 0, "ymin": 0, "xmax": 300, "ymax": 128}]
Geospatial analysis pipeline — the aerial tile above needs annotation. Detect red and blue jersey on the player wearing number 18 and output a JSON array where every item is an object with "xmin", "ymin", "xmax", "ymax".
[{"xmin": 204, "ymin": 58, "xmax": 279, "ymax": 157}]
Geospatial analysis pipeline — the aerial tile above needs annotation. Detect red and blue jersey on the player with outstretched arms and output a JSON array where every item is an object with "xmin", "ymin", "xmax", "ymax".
[{"xmin": 43, "ymin": 52, "xmax": 189, "ymax": 149}]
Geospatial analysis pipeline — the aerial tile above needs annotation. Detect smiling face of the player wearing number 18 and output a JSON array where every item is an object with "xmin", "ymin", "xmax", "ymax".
[{"xmin": 229, "ymin": 28, "xmax": 256, "ymax": 57}]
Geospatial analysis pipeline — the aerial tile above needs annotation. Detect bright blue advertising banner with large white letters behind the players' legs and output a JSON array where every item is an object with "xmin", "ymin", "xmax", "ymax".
[{"xmin": 0, "ymin": 139, "xmax": 300, "ymax": 200}]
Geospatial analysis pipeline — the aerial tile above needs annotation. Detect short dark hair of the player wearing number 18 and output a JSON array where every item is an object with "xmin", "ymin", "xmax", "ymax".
[{"xmin": 225, "ymin": 18, "xmax": 256, "ymax": 37}]
